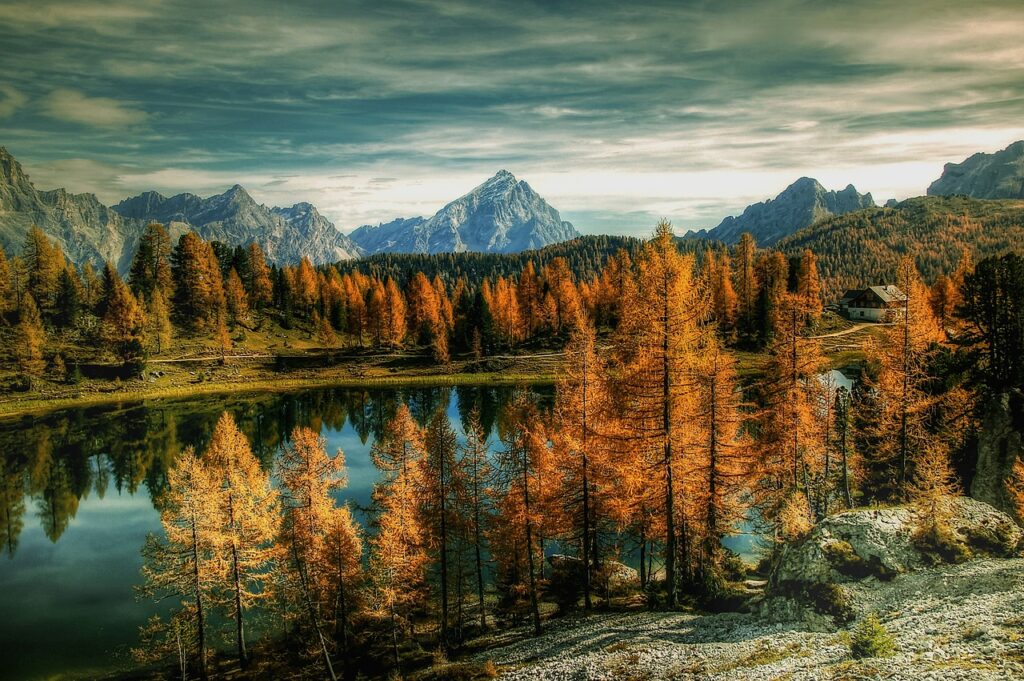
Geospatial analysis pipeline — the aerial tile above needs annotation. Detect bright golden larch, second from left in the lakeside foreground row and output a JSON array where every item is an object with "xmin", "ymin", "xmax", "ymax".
[{"xmin": 203, "ymin": 412, "xmax": 279, "ymax": 666}]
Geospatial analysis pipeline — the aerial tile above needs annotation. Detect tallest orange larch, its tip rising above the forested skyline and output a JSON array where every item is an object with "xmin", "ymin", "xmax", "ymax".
[{"xmin": 615, "ymin": 220, "xmax": 710, "ymax": 607}]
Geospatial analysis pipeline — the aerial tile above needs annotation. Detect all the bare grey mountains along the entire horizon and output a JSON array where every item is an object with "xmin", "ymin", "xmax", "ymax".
[{"xmin": 0, "ymin": 140, "xmax": 1024, "ymax": 271}]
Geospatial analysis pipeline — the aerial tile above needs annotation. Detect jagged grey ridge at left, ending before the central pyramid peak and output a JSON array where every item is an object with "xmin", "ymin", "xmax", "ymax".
[{"xmin": 0, "ymin": 146, "xmax": 360, "ymax": 272}]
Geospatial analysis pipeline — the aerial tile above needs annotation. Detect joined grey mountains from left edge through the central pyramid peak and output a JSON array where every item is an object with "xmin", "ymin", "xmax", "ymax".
[{"xmin": 0, "ymin": 147, "xmax": 579, "ymax": 271}]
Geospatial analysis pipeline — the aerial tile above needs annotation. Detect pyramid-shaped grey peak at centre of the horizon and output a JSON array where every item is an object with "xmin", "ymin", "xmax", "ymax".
[{"xmin": 350, "ymin": 170, "xmax": 580, "ymax": 254}]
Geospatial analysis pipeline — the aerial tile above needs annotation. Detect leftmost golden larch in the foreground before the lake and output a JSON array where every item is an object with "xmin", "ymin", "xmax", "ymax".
[{"xmin": 138, "ymin": 448, "xmax": 223, "ymax": 679}]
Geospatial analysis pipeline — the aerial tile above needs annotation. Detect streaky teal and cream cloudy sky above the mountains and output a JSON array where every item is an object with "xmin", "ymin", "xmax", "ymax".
[{"xmin": 0, "ymin": 0, "xmax": 1024, "ymax": 235}]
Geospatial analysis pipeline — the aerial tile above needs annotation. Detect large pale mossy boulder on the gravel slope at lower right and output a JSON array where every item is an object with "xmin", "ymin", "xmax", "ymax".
[{"xmin": 761, "ymin": 497, "xmax": 1024, "ymax": 627}]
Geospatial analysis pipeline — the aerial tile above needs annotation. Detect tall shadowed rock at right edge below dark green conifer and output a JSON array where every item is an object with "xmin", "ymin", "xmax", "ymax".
[{"xmin": 971, "ymin": 392, "xmax": 1024, "ymax": 513}]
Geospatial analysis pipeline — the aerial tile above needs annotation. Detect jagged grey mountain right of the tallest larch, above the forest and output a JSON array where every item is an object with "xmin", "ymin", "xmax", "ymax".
[{"xmin": 687, "ymin": 177, "xmax": 874, "ymax": 246}]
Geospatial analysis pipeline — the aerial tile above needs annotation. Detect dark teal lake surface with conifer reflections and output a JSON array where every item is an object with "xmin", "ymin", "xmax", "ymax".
[{"xmin": 0, "ymin": 387, "xmax": 552, "ymax": 679}]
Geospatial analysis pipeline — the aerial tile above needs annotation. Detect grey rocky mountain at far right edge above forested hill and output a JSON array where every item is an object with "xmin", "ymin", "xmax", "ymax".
[{"xmin": 928, "ymin": 140, "xmax": 1024, "ymax": 199}]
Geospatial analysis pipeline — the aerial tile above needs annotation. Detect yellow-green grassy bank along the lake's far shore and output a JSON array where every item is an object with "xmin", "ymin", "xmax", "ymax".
[{"xmin": 0, "ymin": 313, "xmax": 874, "ymax": 419}]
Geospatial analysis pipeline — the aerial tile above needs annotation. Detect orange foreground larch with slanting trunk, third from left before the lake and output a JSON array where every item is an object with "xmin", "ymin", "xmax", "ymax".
[{"xmin": 278, "ymin": 426, "xmax": 346, "ymax": 680}]
